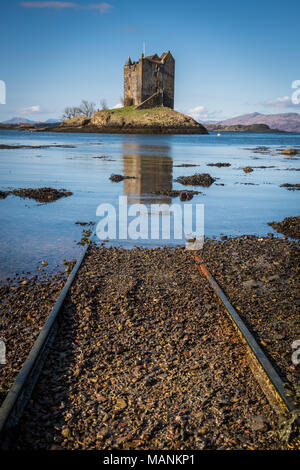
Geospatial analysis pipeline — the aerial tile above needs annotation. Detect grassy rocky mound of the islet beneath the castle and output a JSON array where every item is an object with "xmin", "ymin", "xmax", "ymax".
[{"xmin": 54, "ymin": 106, "xmax": 208, "ymax": 134}]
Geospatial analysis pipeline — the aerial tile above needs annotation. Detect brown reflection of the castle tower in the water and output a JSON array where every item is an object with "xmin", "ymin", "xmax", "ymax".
[{"xmin": 123, "ymin": 143, "xmax": 173, "ymax": 204}]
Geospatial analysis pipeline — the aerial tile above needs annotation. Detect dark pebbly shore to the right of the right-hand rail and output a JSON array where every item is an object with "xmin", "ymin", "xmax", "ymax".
[{"xmin": 199, "ymin": 235, "xmax": 300, "ymax": 394}]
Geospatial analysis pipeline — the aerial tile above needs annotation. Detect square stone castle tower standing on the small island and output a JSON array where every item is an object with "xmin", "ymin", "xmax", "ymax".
[{"xmin": 124, "ymin": 51, "xmax": 175, "ymax": 108}]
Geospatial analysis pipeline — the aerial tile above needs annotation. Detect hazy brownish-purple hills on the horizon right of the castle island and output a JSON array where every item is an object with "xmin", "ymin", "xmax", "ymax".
[{"xmin": 209, "ymin": 113, "xmax": 300, "ymax": 132}]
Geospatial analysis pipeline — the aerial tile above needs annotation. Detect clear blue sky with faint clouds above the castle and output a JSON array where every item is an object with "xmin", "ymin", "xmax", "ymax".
[{"xmin": 0, "ymin": 0, "xmax": 300, "ymax": 121}]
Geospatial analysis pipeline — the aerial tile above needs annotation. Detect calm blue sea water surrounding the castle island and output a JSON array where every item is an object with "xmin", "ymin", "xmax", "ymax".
[{"xmin": 0, "ymin": 130, "xmax": 300, "ymax": 279}]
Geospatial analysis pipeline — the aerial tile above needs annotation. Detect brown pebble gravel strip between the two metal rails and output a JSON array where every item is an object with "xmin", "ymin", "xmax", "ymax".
[{"xmin": 6, "ymin": 242, "xmax": 285, "ymax": 449}]
